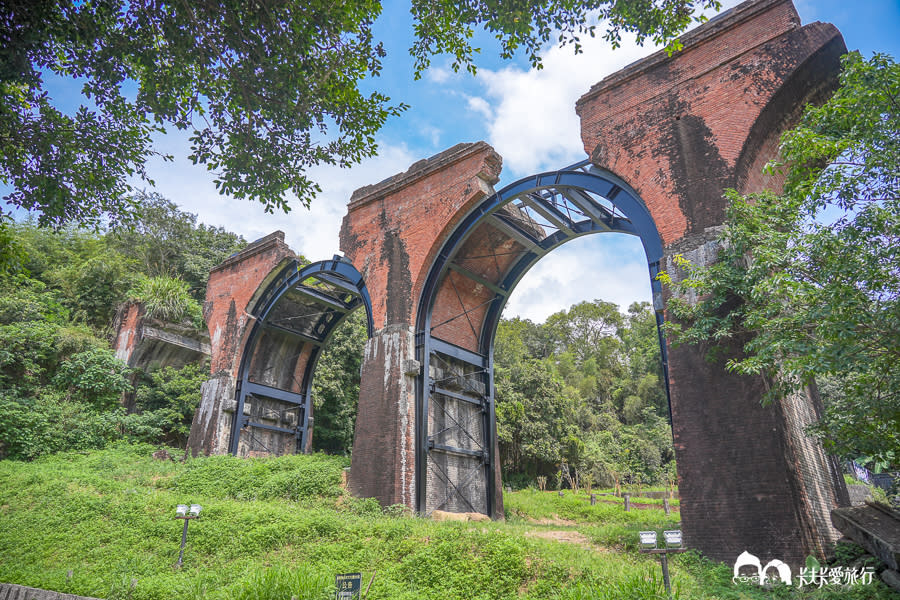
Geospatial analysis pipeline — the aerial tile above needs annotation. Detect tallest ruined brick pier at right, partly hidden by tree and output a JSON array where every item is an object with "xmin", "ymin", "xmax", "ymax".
[{"xmin": 576, "ymin": 0, "xmax": 845, "ymax": 565}]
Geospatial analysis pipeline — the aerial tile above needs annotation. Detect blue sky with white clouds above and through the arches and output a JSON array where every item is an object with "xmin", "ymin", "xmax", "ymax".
[{"xmin": 26, "ymin": 0, "xmax": 900, "ymax": 321}]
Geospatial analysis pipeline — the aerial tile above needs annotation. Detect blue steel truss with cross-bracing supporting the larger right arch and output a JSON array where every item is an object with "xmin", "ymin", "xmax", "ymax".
[{"xmin": 416, "ymin": 161, "xmax": 668, "ymax": 516}]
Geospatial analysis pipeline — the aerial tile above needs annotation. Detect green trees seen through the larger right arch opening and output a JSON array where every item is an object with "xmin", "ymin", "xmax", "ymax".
[{"xmin": 494, "ymin": 300, "xmax": 674, "ymax": 486}]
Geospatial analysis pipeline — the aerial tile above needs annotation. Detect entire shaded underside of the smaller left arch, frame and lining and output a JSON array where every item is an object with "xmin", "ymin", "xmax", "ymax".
[{"xmin": 228, "ymin": 256, "xmax": 373, "ymax": 455}]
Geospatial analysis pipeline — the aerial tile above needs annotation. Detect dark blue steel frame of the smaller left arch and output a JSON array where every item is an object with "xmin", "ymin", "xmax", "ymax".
[{"xmin": 228, "ymin": 255, "xmax": 374, "ymax": 455}]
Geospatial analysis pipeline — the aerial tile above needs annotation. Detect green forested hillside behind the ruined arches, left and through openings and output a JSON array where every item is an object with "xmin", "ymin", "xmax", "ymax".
[{"xmin": 0, "ymin": 194, "xmax": 675, "ymax": 487}]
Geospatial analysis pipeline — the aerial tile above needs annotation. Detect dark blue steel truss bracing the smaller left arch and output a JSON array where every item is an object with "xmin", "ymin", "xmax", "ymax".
[{"xmin": 228, "ymin": 256, "xmax": 373, "ymax": 454}]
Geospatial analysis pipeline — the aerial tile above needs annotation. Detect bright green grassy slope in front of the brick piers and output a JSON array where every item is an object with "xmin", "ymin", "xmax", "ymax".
[{"xmin": 0, "ymin": 445, "xmax": 891, "ymax": 600}]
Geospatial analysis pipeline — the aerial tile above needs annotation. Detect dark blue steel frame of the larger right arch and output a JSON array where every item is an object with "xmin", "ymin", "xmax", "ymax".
[{"xmin": 415, "ymin": 160, "xmax": 671, "ymax": 516}]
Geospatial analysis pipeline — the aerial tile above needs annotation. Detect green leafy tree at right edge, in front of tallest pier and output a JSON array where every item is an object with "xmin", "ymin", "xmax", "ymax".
[{"xmin": 670, "ymin": 53, "xmax": 900, "ymax": 463}]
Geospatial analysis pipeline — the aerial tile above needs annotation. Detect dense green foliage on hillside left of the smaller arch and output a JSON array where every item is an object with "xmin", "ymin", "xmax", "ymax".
[{"xmin": 0, "ymin": 196, "xmax": 244, "ymax": 459}]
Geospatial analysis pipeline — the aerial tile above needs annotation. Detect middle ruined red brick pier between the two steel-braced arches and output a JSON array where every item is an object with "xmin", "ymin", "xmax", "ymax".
[{"xmin": 341, "ymin": 142, "xmax": 501, "ymax": 507}]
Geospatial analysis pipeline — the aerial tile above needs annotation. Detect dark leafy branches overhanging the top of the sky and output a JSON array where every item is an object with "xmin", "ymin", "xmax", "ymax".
[{"xmin": 0, "ymin": 0, "xmax": 719, "ymax": 230}]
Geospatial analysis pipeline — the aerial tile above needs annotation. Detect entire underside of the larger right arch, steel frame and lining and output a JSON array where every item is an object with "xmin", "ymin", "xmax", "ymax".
[{"xmin": 415, "ymin": 161, "xmax": 671, "ymax": 516}]
